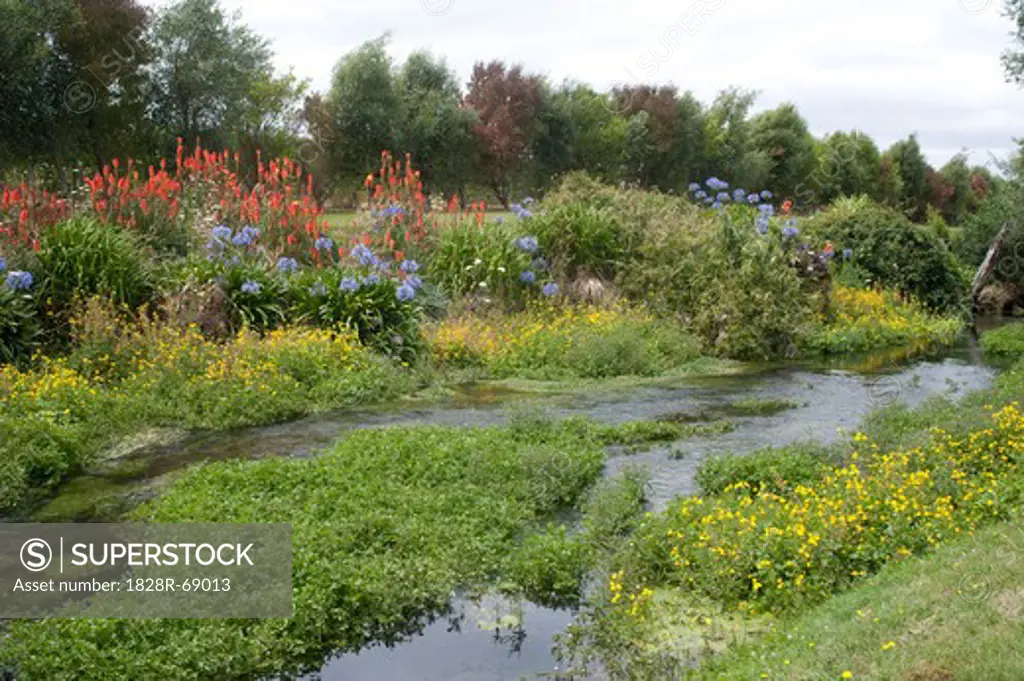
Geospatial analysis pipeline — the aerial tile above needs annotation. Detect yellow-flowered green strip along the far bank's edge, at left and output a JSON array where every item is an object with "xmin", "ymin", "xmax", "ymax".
[{"xmin": 0, "ymin": 323, "xmax": 409, "ymax": 512}]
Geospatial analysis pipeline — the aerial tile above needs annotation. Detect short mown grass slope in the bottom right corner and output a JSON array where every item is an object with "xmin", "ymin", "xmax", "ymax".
[{"xmin": 688, "ymin": 518, "xmax": 1024, "ymax": 681}]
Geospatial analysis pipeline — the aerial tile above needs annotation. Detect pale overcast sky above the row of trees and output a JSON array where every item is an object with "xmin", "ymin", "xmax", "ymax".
[{"xmin": 147, "ymin": 0, "xmax": 1024, "ymax": 165}]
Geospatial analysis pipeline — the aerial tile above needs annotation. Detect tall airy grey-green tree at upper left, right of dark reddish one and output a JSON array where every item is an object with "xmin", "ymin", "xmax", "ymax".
[{"xmin": 150, "ymin": 0, "xmax": 278, "ymax": 147}]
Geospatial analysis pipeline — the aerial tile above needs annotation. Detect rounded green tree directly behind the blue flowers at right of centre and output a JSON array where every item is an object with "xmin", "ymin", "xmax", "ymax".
[{"xmin": 751, "ymin": 103, "xmax": 816, "ymax": 197}]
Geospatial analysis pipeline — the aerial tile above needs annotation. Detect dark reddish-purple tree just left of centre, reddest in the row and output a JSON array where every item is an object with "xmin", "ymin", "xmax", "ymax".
[{"xmin": 465, "ymin": 61, "xmax": 542, "ymax": 208}]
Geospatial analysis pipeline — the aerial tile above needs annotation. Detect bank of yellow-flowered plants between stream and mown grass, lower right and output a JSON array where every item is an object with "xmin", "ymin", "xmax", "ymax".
[{"xmin": 563, "ymin": 356, "xmax": 1024, "ymax": 679}]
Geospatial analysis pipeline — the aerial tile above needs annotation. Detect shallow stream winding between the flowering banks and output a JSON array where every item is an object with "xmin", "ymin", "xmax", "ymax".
[{"xmin": 36, "ymin": 339, "xmax": 996, "ymax": 681}]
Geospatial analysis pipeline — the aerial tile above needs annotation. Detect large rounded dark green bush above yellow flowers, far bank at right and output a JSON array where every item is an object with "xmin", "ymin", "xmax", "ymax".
[{"xmin": 804, "ymin": 197, "xmax": 967, "ymax": 310}]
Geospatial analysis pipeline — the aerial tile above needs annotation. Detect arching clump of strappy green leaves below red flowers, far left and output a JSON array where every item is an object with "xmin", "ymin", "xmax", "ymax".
[{"xmin": 35, "ymin": 217, "xmax": 155, "ymax": 324}]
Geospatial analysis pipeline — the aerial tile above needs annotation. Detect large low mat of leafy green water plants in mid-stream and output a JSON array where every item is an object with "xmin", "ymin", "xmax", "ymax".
[{"xmin": 0, "ymin": 417, "xmax": 603, "ymax": 681}]
